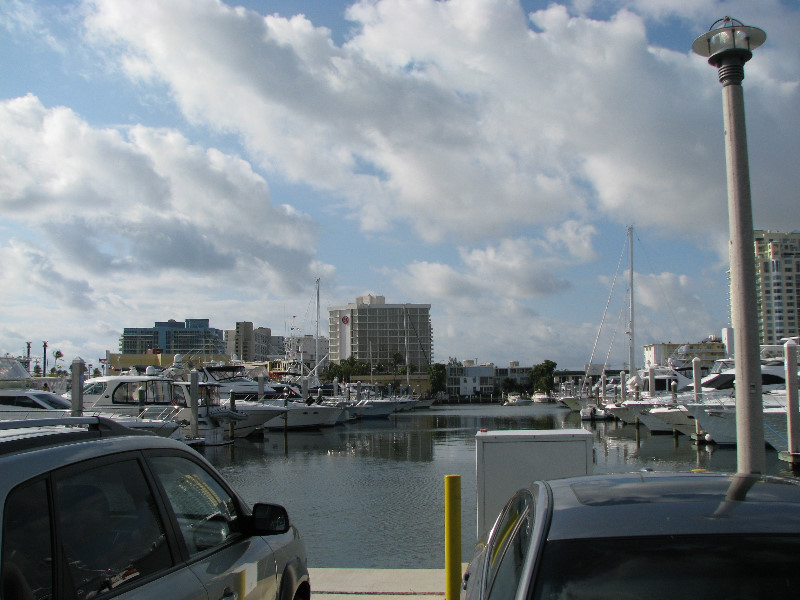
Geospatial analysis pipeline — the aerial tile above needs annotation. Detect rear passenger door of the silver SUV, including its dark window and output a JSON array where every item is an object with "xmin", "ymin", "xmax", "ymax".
[{"xmin": 45, "ymin": 452, "xmax": 208, "ymax": 600}]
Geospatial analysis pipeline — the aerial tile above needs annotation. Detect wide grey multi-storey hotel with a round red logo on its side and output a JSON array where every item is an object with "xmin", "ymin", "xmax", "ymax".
[{"xmin": 328, "ymin": 295, "xmax": 433, "ymax": 372}]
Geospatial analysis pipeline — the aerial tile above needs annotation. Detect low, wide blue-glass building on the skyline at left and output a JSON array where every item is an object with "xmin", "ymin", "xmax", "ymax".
[{"xmin": 119, "ymin": 319, "xmax": 225, "ymax": 356}]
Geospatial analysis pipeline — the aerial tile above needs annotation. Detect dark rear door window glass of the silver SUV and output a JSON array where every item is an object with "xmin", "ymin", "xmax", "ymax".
[{"xmin": 55, "ymin": 459, "xmax": 173, "ymax": 598}]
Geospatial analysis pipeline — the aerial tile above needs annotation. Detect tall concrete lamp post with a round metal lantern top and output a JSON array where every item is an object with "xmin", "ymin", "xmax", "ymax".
[{"xmin": 692, "ymin": 17, "xmax": 767, "ymax": 473}]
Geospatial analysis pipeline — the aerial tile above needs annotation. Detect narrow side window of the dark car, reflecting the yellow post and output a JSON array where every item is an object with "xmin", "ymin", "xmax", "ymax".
[{"xmin": 486, "ymin": 492, "xmax": 533, "ymax": 600}]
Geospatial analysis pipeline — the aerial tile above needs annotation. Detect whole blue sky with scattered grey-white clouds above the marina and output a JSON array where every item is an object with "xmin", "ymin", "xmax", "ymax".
[{"xmin": 0, "ymin": 0, "xmax": 800, "ymax": 369}]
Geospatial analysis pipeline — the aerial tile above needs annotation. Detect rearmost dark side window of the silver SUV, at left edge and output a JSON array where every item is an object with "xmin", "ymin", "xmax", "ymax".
[{"xmin": 0, "ymin": 480, "xmax": 53, "ymax": 600}]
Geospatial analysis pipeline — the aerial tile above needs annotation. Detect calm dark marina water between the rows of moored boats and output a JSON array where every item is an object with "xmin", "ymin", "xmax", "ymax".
[{"xmin": 204, "ymin": 405, "xmax": 791, "ymax": 568}]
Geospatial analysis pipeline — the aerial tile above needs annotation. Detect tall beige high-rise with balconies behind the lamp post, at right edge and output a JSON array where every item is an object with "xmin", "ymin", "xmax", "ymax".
[{"xmin": 753, "ymin": 229, "xmax": 800, "ymax": 345}]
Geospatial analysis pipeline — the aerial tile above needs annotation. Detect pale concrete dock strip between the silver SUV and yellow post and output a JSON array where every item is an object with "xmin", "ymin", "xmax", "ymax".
[{"xmin": 308, "ymin": 568, "xmax": 445, "ymax": 600}]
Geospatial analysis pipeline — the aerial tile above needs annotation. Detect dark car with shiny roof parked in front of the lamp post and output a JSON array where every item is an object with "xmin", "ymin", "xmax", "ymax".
[{"xmin": 461, "ymin": 471, "xmax": 800, "ymax": 600}]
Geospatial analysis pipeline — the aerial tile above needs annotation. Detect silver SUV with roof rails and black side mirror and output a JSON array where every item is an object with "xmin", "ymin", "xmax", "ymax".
[{"xmin": 0, "ymin": 416, "xmax": 311, "ymax": 600}]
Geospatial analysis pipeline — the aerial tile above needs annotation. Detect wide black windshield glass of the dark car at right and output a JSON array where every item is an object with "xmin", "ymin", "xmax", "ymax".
[{"xmin": 533, "ymin": 535, "xmax": 800, "ymax": 600}]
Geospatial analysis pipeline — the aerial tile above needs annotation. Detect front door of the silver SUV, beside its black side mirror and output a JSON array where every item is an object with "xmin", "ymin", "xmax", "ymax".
[{"xmin": 148, "ymin": 453, "xmax": 278, "ymax": 600}]
